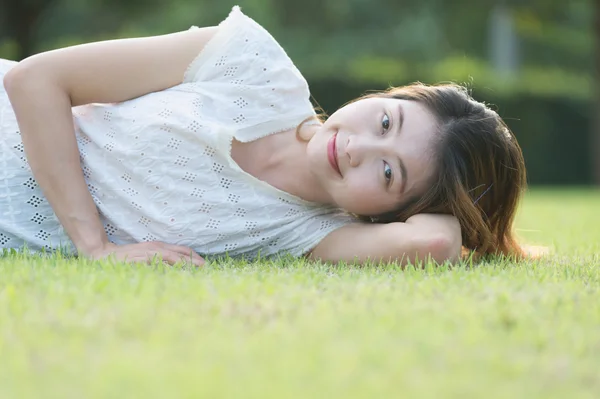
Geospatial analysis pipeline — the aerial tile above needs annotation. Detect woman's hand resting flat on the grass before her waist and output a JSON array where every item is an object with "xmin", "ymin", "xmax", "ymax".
[{"xmin": 88, "ymin": 241, "xmax": 204, "ymax": 266}]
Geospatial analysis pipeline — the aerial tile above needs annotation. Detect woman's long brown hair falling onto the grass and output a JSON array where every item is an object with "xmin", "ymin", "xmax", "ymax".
[{"xmin": 310, "ymin": 83, "xmax": 526, "ymax": 257}]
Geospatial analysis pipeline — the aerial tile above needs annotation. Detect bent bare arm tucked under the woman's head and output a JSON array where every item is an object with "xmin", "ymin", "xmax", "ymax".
[{"xmin": 309, "ymin": 214, "xmax": 462, "ymax": 264}]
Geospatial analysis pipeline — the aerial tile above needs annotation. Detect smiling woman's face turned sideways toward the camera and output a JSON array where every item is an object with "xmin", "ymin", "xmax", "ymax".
[{"xmin": 307, "ymin": 97, "xmax": 436, "ymax": 216}]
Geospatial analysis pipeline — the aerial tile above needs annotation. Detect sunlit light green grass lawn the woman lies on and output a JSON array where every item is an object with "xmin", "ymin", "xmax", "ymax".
[{"xmin": 0, "ymin": 189, "xmax": 600, "ymax": 398}]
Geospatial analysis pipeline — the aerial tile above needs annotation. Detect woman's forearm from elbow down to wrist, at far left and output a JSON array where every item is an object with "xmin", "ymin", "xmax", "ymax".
[{"xmin": 4, "ymin": 73, "xmax": 108, "ymax": 254}]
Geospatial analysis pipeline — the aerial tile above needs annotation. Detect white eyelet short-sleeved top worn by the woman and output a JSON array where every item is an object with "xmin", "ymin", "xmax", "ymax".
[{"xmin": 0, "ymin": 7, "xmax": 352, "ymax": 258}]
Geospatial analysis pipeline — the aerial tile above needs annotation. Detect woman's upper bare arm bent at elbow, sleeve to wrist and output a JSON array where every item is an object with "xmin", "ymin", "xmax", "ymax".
[{"xmin": 4, "ymin": 27, "xmax": 218, "ymax": 255}]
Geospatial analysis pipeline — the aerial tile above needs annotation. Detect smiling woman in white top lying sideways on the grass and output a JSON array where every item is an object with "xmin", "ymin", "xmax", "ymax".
[{"xmin": 0, "ymin": 8, "xmax": 525, "ymax": 264}]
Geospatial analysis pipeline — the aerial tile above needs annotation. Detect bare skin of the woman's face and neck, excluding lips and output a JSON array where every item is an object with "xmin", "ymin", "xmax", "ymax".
[{"xmin": 244, "ymin": 97, "xmax": 437, "ymax": 216}]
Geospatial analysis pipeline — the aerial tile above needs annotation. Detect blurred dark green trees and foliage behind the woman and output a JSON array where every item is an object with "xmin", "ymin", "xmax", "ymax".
[{"xmin": 0, "ymin": 0, "xmax": 600, "ymax": 185}]
